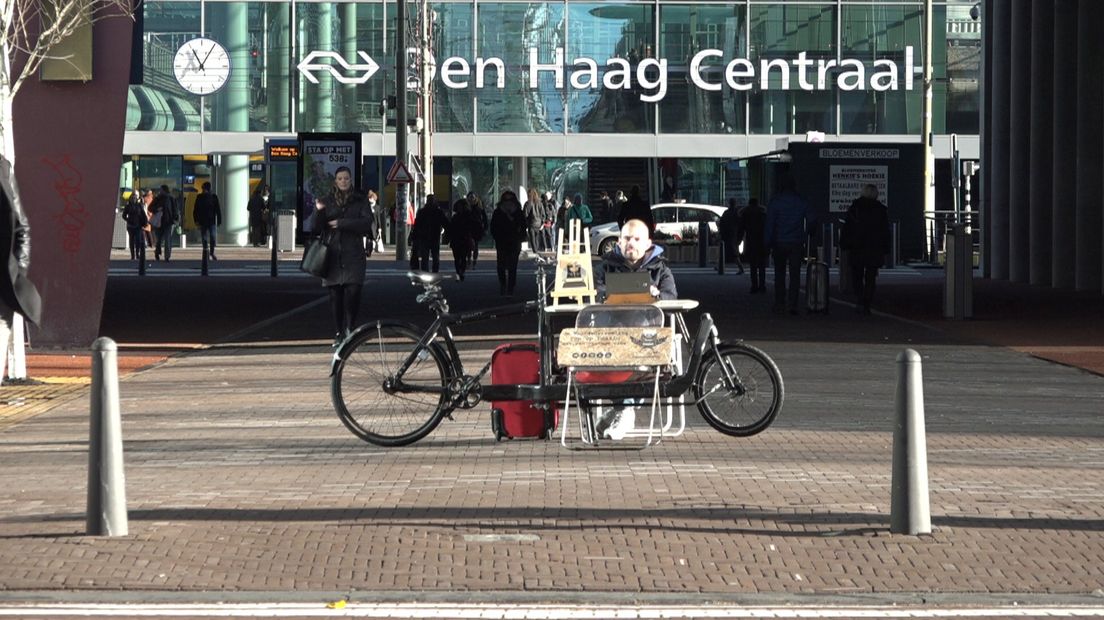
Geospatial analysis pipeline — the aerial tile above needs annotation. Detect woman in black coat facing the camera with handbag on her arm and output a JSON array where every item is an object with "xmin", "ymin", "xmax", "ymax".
[{"xmin": 310, "ymin": 165, "xmax": 374, "ymax": 346}]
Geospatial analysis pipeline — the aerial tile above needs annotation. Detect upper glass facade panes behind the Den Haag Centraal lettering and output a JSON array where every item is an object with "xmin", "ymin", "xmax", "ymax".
[{"xmin": 128, "ymin": 0, "xmax": 980, "ymax": 136}]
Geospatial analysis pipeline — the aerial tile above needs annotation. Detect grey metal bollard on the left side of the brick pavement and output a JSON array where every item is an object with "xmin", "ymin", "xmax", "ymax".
[{"xmin": 85, "ymin": 338, "xmax": 127, "ymax": 536}]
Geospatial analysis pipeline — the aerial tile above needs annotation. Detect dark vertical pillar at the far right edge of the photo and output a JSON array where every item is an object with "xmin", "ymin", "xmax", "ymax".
[{"xmin": 1074, "ymin": 0, "xmax": 1104, "ymax": 291}]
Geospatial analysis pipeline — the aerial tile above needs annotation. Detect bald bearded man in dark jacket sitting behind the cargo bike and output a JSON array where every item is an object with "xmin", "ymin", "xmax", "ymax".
[{"xmin": 594, "ymin": 220, "xmax": 679, "ymax": 439}]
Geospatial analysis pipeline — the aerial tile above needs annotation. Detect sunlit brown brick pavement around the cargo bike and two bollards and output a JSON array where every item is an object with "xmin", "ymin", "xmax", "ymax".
[{"xmin": 0, "ymin": 258, "xmax": 1104, "ymax": 599}]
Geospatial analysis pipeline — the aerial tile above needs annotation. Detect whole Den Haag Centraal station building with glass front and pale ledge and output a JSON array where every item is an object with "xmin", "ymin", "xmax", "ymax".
[{"xmin": 120, "ymin": 0, "xmax": 981, "ymax": 253}]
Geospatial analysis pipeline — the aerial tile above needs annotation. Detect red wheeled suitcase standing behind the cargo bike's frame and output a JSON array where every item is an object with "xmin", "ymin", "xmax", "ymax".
[{"xmin": 490, "ymin": 342, "xmax": 560, "ymax": 440}]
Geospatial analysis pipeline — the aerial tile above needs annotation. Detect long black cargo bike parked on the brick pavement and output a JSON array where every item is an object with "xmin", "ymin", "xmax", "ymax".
[{"xmin": 330, "ymin": 254, "xmax": 785, "ymax": 447}]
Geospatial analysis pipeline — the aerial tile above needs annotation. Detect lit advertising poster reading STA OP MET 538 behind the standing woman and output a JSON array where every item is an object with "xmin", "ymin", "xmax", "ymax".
[{"xmin": 299, "ymin": 133, "xmax": 360, "ymax": 233}]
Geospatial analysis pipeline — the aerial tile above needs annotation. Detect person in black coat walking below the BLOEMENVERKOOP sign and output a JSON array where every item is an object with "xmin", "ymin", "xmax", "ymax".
[{"xmin": 839, "ymin": 180, "xmax": 891, "ymax": 314}]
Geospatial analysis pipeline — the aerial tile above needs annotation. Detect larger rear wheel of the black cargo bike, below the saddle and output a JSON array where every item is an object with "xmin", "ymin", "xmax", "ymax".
[{"xmin": 330, "ymin": 322, "xmax": 448, "ymax": 447}]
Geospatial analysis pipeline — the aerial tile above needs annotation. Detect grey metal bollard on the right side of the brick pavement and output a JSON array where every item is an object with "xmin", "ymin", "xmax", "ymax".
[{"xmin": 890, "ymin": 349, "xmax": 932, "ymax": 535}]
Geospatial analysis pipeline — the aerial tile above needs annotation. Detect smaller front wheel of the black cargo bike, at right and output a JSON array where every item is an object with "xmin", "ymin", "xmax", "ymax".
[{"xmin": 693, "ymin": 342, "xmax": 786, "ymax": 437}]
